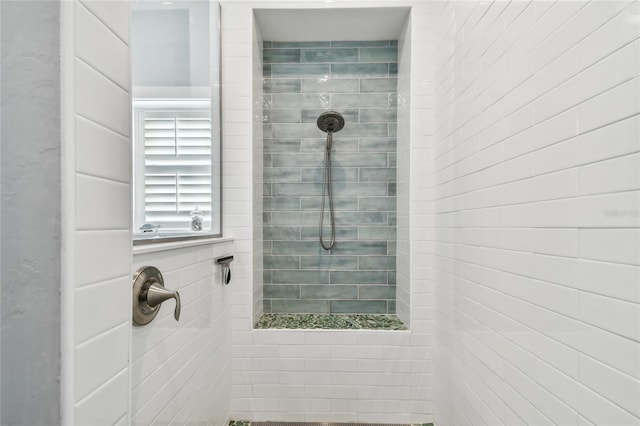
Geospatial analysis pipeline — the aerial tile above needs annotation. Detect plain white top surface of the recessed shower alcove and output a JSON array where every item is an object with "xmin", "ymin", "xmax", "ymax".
[{"xmin": 254, "ymin": 7, "xmax": 409, "ymax": 41}]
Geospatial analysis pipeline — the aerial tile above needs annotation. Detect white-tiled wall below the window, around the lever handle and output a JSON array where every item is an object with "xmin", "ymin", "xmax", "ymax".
[{"xmin": 131, "ymin": 241, "xmax": 235, "ymax": 426}]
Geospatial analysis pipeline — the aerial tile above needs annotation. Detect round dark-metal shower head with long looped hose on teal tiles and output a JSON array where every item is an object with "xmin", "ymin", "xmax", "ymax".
[{"xmin": 317, "ymin": 111, "xmax": 344, "ymax": 250}]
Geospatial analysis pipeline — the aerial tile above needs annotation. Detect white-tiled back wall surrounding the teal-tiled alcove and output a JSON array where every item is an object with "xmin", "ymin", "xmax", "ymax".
[{"xmin": 222, "ymin": 1, "xmax": 433, "ymax": 423}]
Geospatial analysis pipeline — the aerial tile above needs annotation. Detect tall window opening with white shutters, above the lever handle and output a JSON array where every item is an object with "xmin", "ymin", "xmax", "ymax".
[{"xmin": 130, "ymin": 0, "xmax": 221, "ymax": 241}]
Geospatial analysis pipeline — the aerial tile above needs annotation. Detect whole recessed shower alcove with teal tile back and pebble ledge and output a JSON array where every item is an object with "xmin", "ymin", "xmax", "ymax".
[{"xmin": 253, "ymin": 7, "xmax": 411, "ymax": 329}]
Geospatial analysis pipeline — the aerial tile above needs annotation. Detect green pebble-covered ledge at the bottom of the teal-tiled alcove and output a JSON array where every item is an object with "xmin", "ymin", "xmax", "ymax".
[{"xmin": 256, "ymin": 314, "xmax": 407, "ymax": 330}]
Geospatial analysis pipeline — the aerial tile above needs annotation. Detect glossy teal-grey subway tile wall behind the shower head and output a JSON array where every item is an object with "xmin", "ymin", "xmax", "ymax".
[{"xmin": 263, "ymin": 40, "xmax": 398, "ymax": 314}]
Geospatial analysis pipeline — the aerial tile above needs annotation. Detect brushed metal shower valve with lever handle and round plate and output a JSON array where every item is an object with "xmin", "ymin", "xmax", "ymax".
[{"xmin": 133, "ymin": 266, "xmax": 180, "ymax": 325}]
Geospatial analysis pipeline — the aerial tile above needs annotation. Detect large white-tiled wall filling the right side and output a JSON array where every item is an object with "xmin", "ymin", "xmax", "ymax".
[{"xmin": 433, "ymin": 1, "xmax": 640, "ymax": 426}]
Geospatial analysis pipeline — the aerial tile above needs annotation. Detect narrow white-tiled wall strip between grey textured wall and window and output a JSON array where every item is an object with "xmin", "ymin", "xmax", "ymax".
[{"xmin": 61, "ymin": 1, "xmax": 131, "ymax": 425}]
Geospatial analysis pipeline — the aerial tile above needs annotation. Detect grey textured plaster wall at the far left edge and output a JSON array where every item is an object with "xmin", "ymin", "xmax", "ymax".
[{"xmin": 0, "ymin": 2, "xmax": 61, "ymax": 425}]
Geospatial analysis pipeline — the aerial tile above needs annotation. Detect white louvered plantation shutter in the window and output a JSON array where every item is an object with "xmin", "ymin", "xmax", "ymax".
[{"xmin": 136, "ymin": 102, "xmax": 212, "ymax": 229}]
